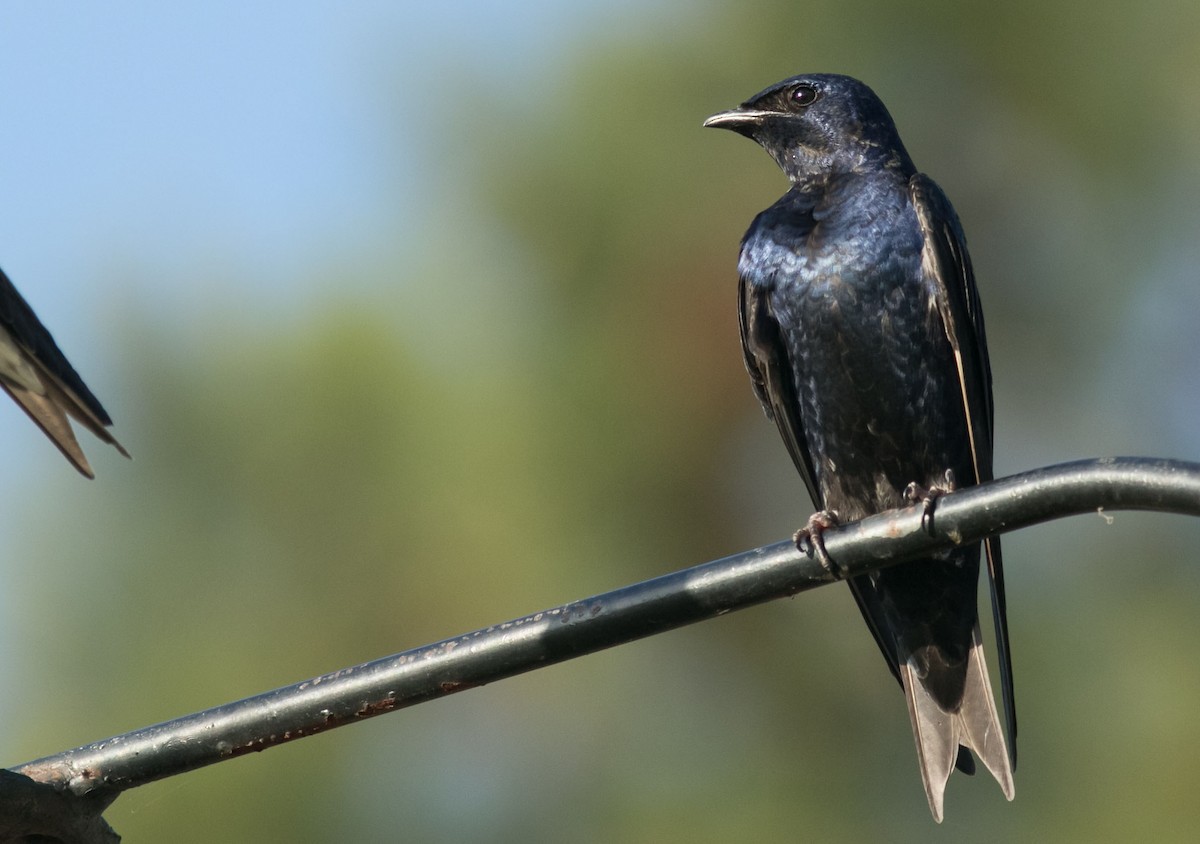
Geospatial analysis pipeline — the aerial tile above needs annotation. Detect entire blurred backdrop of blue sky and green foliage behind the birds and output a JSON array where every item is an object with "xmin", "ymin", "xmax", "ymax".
[{"xmin": 0, "ymin": 0, "xmax": 1200, "ymax": 842}]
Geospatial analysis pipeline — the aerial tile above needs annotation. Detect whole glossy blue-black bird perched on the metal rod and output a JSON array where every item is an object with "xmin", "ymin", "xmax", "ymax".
[{"xmin": 704, "ymin": 73, "xmax": 1016, "ymax": 822}]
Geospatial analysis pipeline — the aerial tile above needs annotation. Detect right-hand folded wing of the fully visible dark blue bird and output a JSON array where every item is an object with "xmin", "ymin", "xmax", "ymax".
[{"xmin": 908, "ymin": 173, "xmax": 1016, "ymax": 768}]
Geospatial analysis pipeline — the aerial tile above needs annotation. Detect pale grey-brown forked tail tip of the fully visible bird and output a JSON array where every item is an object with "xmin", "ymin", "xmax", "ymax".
[{"xmin": 900, "ymin": 624, "xmax": 1015, "ymax": 824}]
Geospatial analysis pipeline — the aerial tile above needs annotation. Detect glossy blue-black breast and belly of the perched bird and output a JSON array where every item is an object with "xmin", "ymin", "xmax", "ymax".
[{"xmin": 751, "ymin": 201, "xmax": 966, "ymax": 517}]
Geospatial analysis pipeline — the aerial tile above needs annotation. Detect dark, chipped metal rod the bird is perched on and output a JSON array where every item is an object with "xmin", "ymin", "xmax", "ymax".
[{"xmin": 11, "ymin": 457, "xmax": 1200, "ymax": 795}]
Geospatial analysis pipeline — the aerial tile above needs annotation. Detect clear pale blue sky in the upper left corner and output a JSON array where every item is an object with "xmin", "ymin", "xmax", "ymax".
[{"xmin": 0, "ymin": 0, "xmax": 676, "ymax": 340}]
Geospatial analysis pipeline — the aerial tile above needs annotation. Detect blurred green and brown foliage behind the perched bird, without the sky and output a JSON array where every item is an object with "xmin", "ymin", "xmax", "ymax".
[{"xmin": 6, "ymin": 0, "xmax": 1200, "ymax": 842}]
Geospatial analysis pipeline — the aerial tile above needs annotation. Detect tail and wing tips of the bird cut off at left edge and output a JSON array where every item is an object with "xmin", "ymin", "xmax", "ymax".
[{"xmin": 0, "ymin": 270, "xmax": 130, "ymax": 478}]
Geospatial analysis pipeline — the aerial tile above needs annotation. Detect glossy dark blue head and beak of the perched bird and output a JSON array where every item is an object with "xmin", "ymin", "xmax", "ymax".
[{"xmin": 704, "ymin": 73, "xmax": 912, "ymax": 181}]
